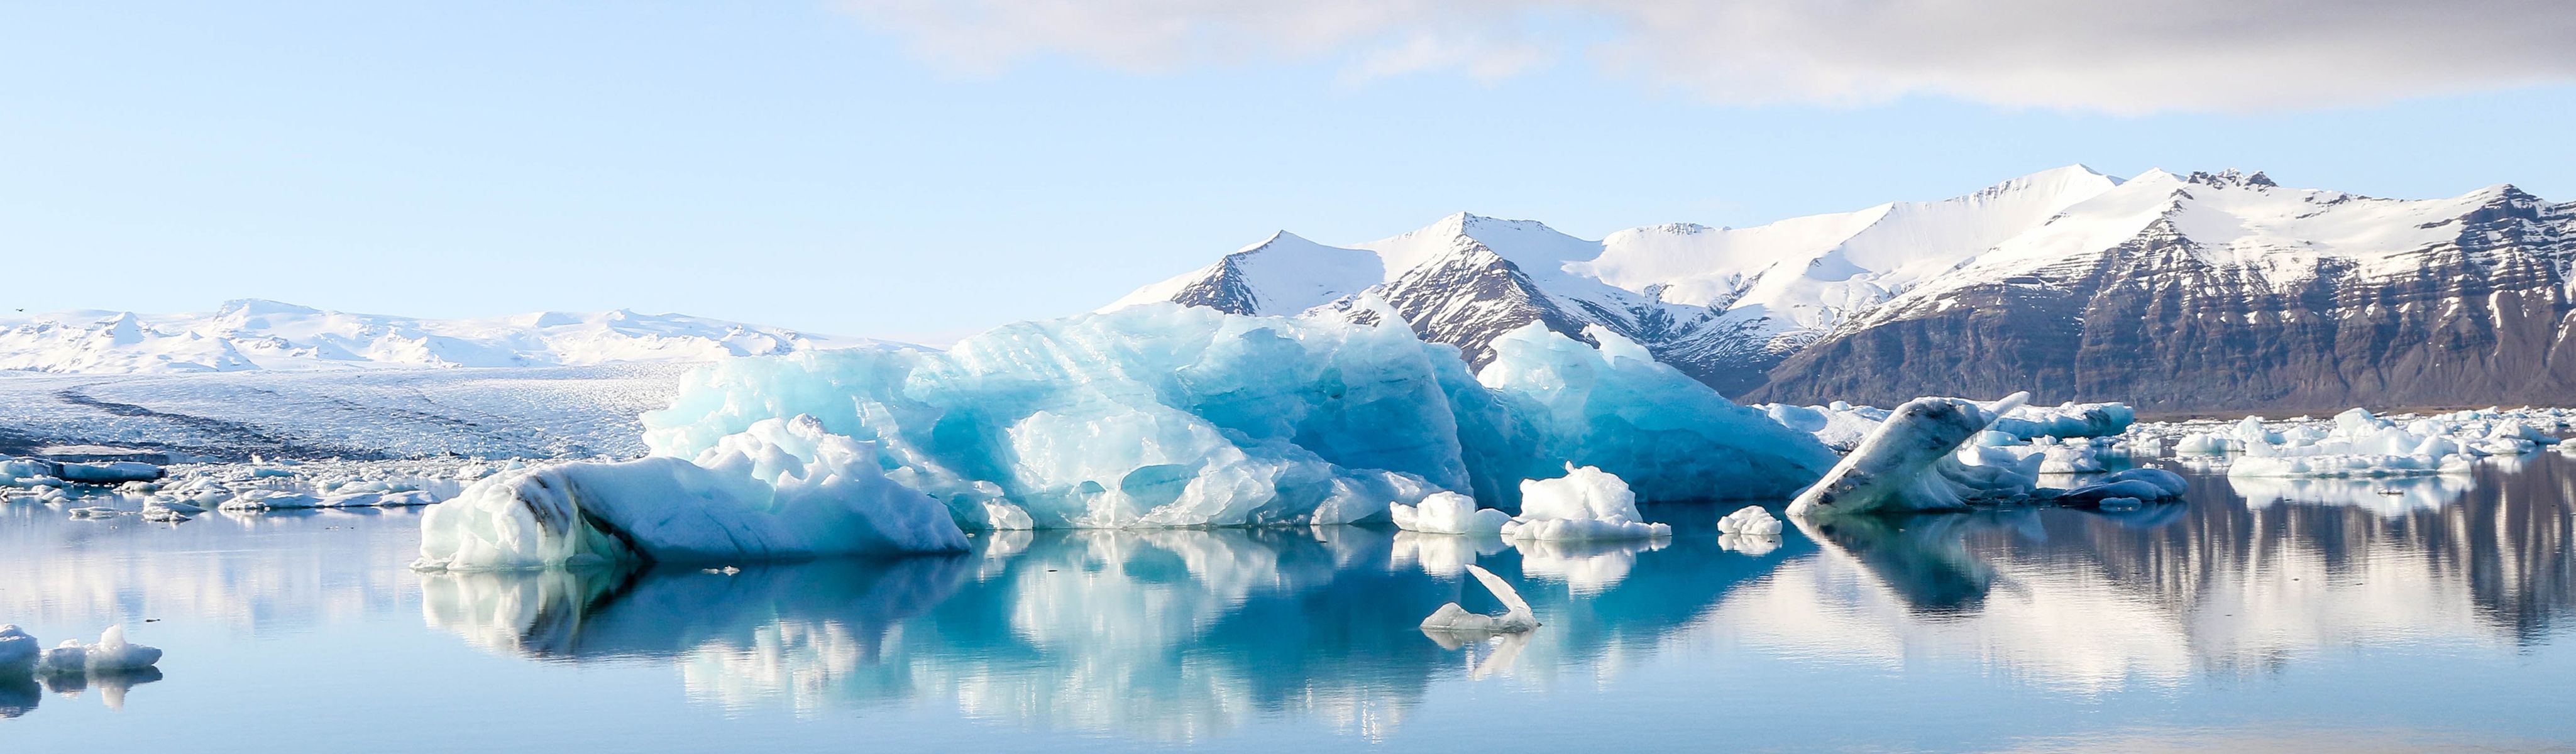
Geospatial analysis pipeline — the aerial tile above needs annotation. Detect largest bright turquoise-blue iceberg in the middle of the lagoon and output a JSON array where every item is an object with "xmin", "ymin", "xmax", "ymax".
[{"xmin": 644, "ymin": 303, "xmax": 1832, "ymax": 528}]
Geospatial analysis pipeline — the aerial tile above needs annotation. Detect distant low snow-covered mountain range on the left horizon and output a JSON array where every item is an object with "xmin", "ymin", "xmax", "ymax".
[{"xmin": 0, "ymin": 298, "xmax": 884, "ymax": 373}]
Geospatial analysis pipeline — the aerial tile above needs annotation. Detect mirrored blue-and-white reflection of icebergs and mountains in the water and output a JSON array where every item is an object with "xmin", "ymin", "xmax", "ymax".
[{"xmin": 420, "ymin": 456, "xmax": 2576, "ymax": 741}]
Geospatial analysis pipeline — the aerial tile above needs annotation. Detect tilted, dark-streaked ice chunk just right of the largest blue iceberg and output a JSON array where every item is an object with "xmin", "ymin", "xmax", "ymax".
[{"xmin": 1788, "ymin": 394, "xmax": 2035, "ymax": 515}]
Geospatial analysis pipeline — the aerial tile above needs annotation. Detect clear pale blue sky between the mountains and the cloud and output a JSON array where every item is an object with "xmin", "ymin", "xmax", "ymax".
[{"xmin": 0, "ymin": 0, "xmax": 2576, "ymax": 340}]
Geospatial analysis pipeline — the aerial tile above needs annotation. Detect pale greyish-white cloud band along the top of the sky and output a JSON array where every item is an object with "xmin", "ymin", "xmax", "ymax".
[{"xmin": 842, "ymin": 0, "xmax": 2576, "ymax": 113}]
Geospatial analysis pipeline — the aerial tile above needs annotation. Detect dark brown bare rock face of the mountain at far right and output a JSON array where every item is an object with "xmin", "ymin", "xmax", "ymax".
[{"xmin": 1749, "ymin": 180, "xmax": 2576, "ymax": 412}]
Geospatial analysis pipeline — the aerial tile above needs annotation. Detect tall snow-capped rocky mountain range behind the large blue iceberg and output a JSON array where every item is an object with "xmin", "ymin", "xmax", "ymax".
[{"xmin": 1110, "ymin": 165, "xmax": 2576, "ymax": 409}]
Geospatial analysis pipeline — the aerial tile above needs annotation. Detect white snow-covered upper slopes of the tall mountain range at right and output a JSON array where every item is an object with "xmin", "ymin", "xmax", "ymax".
[{"xmin": 1108, "ymin": 165, "xmax": 2576, "ymax": 404}]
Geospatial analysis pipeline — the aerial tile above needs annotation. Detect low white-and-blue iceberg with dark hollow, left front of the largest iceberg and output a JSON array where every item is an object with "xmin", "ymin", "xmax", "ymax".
[{"xmin": 412, "ymin": 417, "xmax": 966, "ymax": 571}]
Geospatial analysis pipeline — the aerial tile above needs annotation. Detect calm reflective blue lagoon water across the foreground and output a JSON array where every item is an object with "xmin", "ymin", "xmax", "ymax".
[{"xmin": 0, "ymin": 453, "xmax": 2576, "ymax": 751}]
